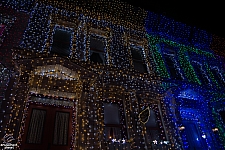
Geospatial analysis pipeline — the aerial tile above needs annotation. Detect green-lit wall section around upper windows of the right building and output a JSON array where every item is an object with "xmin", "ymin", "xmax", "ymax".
[{"xmin": 147, "ymin": 34, "xmax": 216, "ymax": 85}]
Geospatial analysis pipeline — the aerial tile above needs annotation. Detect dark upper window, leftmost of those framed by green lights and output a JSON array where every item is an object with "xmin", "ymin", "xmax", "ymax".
[{"xmin": 164, "ymin": 55, "xmax": 182, "ymax": 80}]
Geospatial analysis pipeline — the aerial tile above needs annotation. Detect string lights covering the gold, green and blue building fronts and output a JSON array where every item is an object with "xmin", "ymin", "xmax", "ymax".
[{"xmin": 0, "ymin": 0, "xmax": 225, "ymax": 150}]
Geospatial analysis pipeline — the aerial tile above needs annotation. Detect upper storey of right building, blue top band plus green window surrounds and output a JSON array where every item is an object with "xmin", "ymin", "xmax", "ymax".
[{"xmin": 146, "ymin": 12, "xmax": 224, "ymax": 86}]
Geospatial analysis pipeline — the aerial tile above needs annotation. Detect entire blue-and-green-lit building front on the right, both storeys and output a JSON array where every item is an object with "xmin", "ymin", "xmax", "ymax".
[{"xmin": 146, "ymin": 12, "xmax": 225, "ymax": 149}]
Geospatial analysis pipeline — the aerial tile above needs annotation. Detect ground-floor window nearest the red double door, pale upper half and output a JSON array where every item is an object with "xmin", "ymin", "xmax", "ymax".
[{"xmin": 103, "ymin": 103, "xmax": 126, "ymax": 141}]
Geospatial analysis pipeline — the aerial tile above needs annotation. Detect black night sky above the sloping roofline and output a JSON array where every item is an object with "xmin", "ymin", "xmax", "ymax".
[{"xmin": 122, "ymin": 0, "xmax": 225, "ymax": 38}]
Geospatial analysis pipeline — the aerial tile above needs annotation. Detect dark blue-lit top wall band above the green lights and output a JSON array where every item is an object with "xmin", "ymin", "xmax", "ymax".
[{"xmin": 145, "ymin": 12, "xmax": 212, "ymax": 50}]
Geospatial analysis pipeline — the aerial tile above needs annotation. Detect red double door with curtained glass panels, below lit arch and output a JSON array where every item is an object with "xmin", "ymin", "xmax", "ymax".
[{"xmin": 21, "ymin": 104, "xmax": 72, "ymax": 150}]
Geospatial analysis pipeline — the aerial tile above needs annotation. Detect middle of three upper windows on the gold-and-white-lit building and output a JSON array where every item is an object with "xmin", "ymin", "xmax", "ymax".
[{"xmin": 90, "ymin": 37, "xmax": 105, "ymax": 64}]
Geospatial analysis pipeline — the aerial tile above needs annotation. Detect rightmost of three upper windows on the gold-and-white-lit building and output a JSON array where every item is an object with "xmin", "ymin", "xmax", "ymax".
[{"xmin": 131, "ymin": 48, "xmax": 148, "ymax": 73}]
